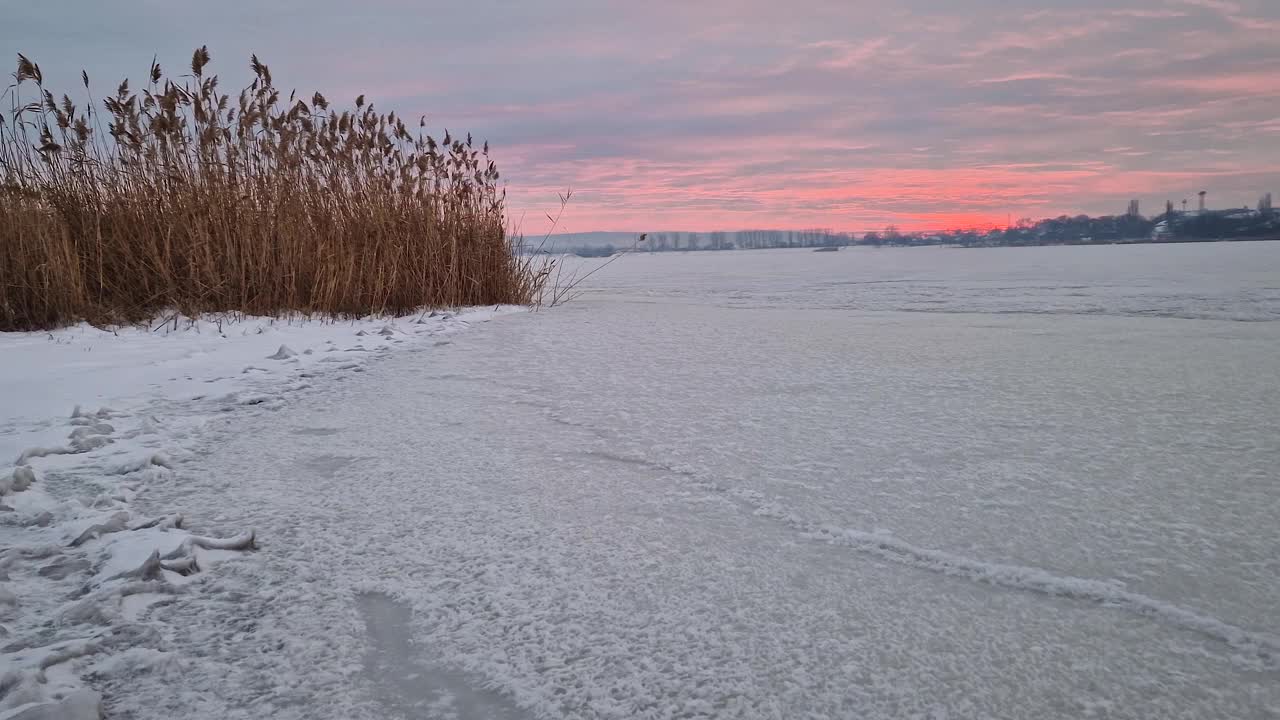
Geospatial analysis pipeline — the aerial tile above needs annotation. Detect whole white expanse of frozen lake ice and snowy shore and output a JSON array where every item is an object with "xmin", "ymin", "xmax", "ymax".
[{"xmin": 0, "ymin": 243, "xmax": 1280, "ymax": 720}]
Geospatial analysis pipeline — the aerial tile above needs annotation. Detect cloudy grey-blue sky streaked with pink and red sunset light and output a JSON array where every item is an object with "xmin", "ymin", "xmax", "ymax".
[{"xmin": 0, "ymin": 0, "xmax": 1280, "ymax": 233}]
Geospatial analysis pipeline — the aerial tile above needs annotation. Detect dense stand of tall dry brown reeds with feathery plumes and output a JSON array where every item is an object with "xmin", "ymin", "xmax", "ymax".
[{"xmin": 0, "ymin": 47, "xmax": 547, "ymax": 331}]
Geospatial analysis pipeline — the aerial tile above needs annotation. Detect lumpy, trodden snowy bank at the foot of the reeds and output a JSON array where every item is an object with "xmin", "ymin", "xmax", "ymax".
[{"xmin": 0, "ymin": 307, "xmax": 518, "ymax": 720}]
